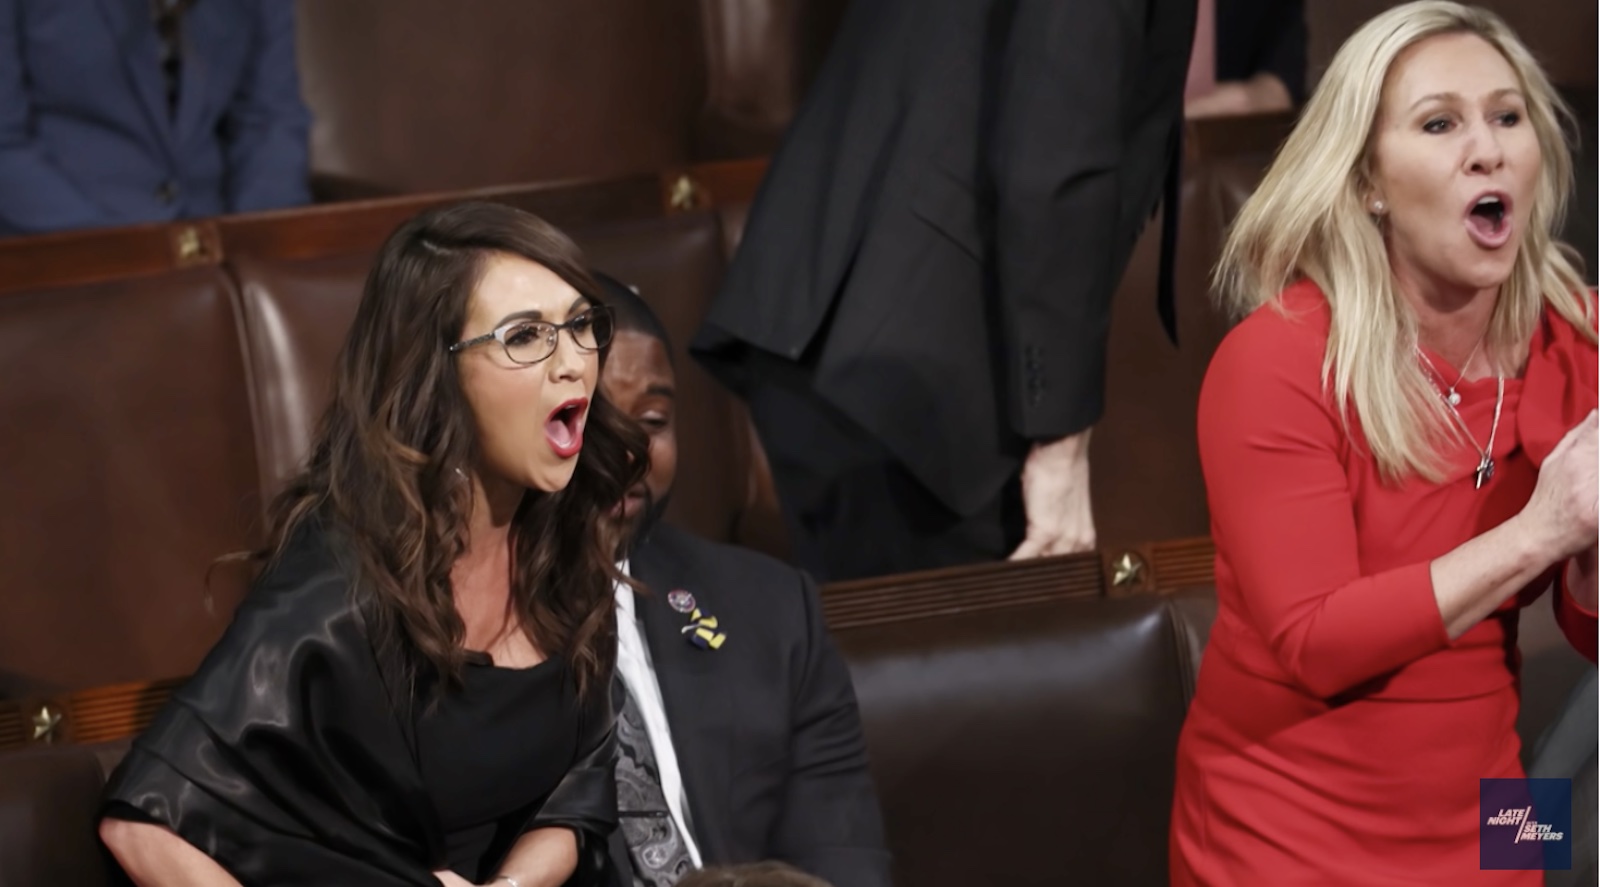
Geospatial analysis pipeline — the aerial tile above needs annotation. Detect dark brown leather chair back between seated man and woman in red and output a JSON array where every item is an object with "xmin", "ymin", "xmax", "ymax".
[{"xmin": 837, "ymin": 585, "xmax": 1189, "ymax": 887}]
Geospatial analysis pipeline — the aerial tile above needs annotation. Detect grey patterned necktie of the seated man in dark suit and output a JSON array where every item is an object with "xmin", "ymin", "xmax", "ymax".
[{"xmin": 614, "ymin": 677, "xmax": 694, "ymax": 887}]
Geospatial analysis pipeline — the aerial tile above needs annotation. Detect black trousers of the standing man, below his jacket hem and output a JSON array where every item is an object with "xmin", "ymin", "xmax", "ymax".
[{"xmin": 749, "ymin": 384, "xmax": 1026, "ymax": 581}]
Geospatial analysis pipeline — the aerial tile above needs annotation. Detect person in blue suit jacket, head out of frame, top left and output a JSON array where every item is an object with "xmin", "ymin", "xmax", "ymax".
[{"xmin": 0, "ymin": 0, "xmax": 310, "ymax": 237}]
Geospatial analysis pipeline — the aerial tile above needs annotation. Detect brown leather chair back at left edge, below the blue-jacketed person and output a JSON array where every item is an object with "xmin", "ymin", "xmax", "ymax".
[{"xmin": 0, "ymin": 267, "xmax": 259, "ymax": 698}]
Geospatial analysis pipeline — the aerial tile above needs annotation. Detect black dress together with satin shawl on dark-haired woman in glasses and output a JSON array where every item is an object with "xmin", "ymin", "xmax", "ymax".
[{"xmin": 106, "ymin": 524, "xmax": 616, "ymax": 887}]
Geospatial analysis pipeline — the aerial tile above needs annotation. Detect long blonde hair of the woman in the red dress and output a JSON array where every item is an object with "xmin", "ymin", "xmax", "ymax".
[{"xmin": 1213, "ymin": 0, "xmax": 1594, "ymax": 482}]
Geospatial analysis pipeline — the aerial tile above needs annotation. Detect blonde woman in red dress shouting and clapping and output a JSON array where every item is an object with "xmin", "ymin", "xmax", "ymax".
[{"xmin": 1171, "ymin": 2, "xmax": 1597, "ymax": 887}]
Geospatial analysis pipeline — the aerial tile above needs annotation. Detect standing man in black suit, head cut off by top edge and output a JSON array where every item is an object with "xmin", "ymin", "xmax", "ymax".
[{"xmin": 693, "ymin": 0, "xmax": 1195, "ymax": 580}]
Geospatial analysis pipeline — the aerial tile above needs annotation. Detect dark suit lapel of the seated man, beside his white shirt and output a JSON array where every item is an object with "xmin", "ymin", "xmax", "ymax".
[{"xmin": 632, "ymin": 532, "xmax": 733, "ymax": 863}]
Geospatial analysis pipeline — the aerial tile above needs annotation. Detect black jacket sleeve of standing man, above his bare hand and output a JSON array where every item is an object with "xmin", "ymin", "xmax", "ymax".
[{"xmin": 986, "ymin": 0, "xmax": 1144, "ymax": 440}]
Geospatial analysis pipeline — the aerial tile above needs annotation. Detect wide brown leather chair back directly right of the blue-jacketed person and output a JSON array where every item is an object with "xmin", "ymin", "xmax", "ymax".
[{"xmin": 298, "ymin": 0, "xmax": 704, "ymax": 192}]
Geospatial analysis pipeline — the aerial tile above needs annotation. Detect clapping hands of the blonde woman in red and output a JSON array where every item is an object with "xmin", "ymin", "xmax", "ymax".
[{"xmin": 1520, "ymin": 410, "xmax": 1600, "ymax": 564}]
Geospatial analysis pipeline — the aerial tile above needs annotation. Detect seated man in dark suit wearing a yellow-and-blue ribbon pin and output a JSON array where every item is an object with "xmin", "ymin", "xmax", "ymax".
[{"xmin": 600, "ymin": 277, "xmax": 890, "ymax": 887}]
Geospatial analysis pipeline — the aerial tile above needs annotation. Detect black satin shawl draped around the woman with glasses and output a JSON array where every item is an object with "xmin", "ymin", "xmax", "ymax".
[{"xmin": 106, "ymin": 522, "xmax": 616, "ymax": 887}]
